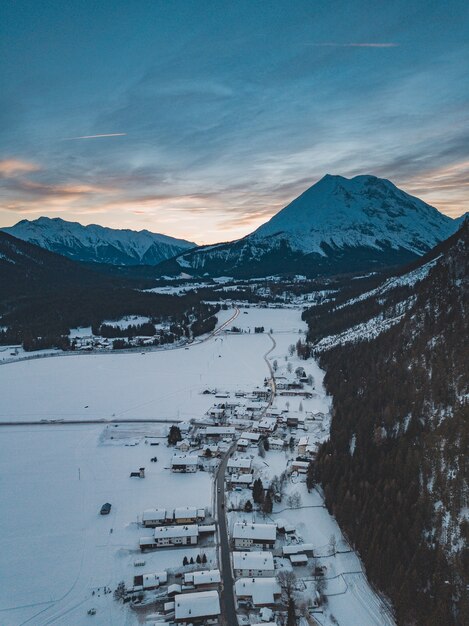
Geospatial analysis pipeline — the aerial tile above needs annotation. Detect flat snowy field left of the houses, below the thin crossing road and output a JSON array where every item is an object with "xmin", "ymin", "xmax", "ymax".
[{"xmin": 0, "ymin": 425, "xmax": 215, "ymax": 626}]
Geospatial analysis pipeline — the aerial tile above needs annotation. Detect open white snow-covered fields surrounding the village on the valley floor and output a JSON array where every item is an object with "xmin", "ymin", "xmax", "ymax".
[{"xmin": 0, "ymin": 308, "xmax": 391, "ymax": 626}]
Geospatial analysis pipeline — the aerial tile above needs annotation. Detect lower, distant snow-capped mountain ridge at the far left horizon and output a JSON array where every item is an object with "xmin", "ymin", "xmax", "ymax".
[{"xmin": 2, "ymin": 217, "xmax": 195, "ymax": 265}]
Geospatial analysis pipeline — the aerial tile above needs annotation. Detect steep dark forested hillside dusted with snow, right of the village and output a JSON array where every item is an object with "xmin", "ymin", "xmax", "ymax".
[{"xmin": 306, "ymin": 221, "xmax": 469, "ymax": 626}]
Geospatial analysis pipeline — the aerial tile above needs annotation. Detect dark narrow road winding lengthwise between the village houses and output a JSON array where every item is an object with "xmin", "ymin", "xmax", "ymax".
[{"xmin": 215, "ymin": 330, "xmax": 277, "ymax": 626}]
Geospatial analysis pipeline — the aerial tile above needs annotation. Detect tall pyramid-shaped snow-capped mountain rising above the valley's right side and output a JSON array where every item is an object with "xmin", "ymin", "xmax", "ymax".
[{"xmin": 163, "ymin": 175, "xmax": 459, "ymax": 276}]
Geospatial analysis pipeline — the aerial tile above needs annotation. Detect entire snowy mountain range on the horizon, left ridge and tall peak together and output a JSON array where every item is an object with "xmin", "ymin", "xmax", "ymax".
[{"xmin": 3, "ymin": 175, "xmax": 464, "ymax": 278}]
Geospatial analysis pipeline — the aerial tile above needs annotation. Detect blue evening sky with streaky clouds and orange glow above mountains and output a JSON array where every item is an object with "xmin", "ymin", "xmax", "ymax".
[{"xmin": 0, "ymin": 0, "xmax": 469, "ymax": 243}]
